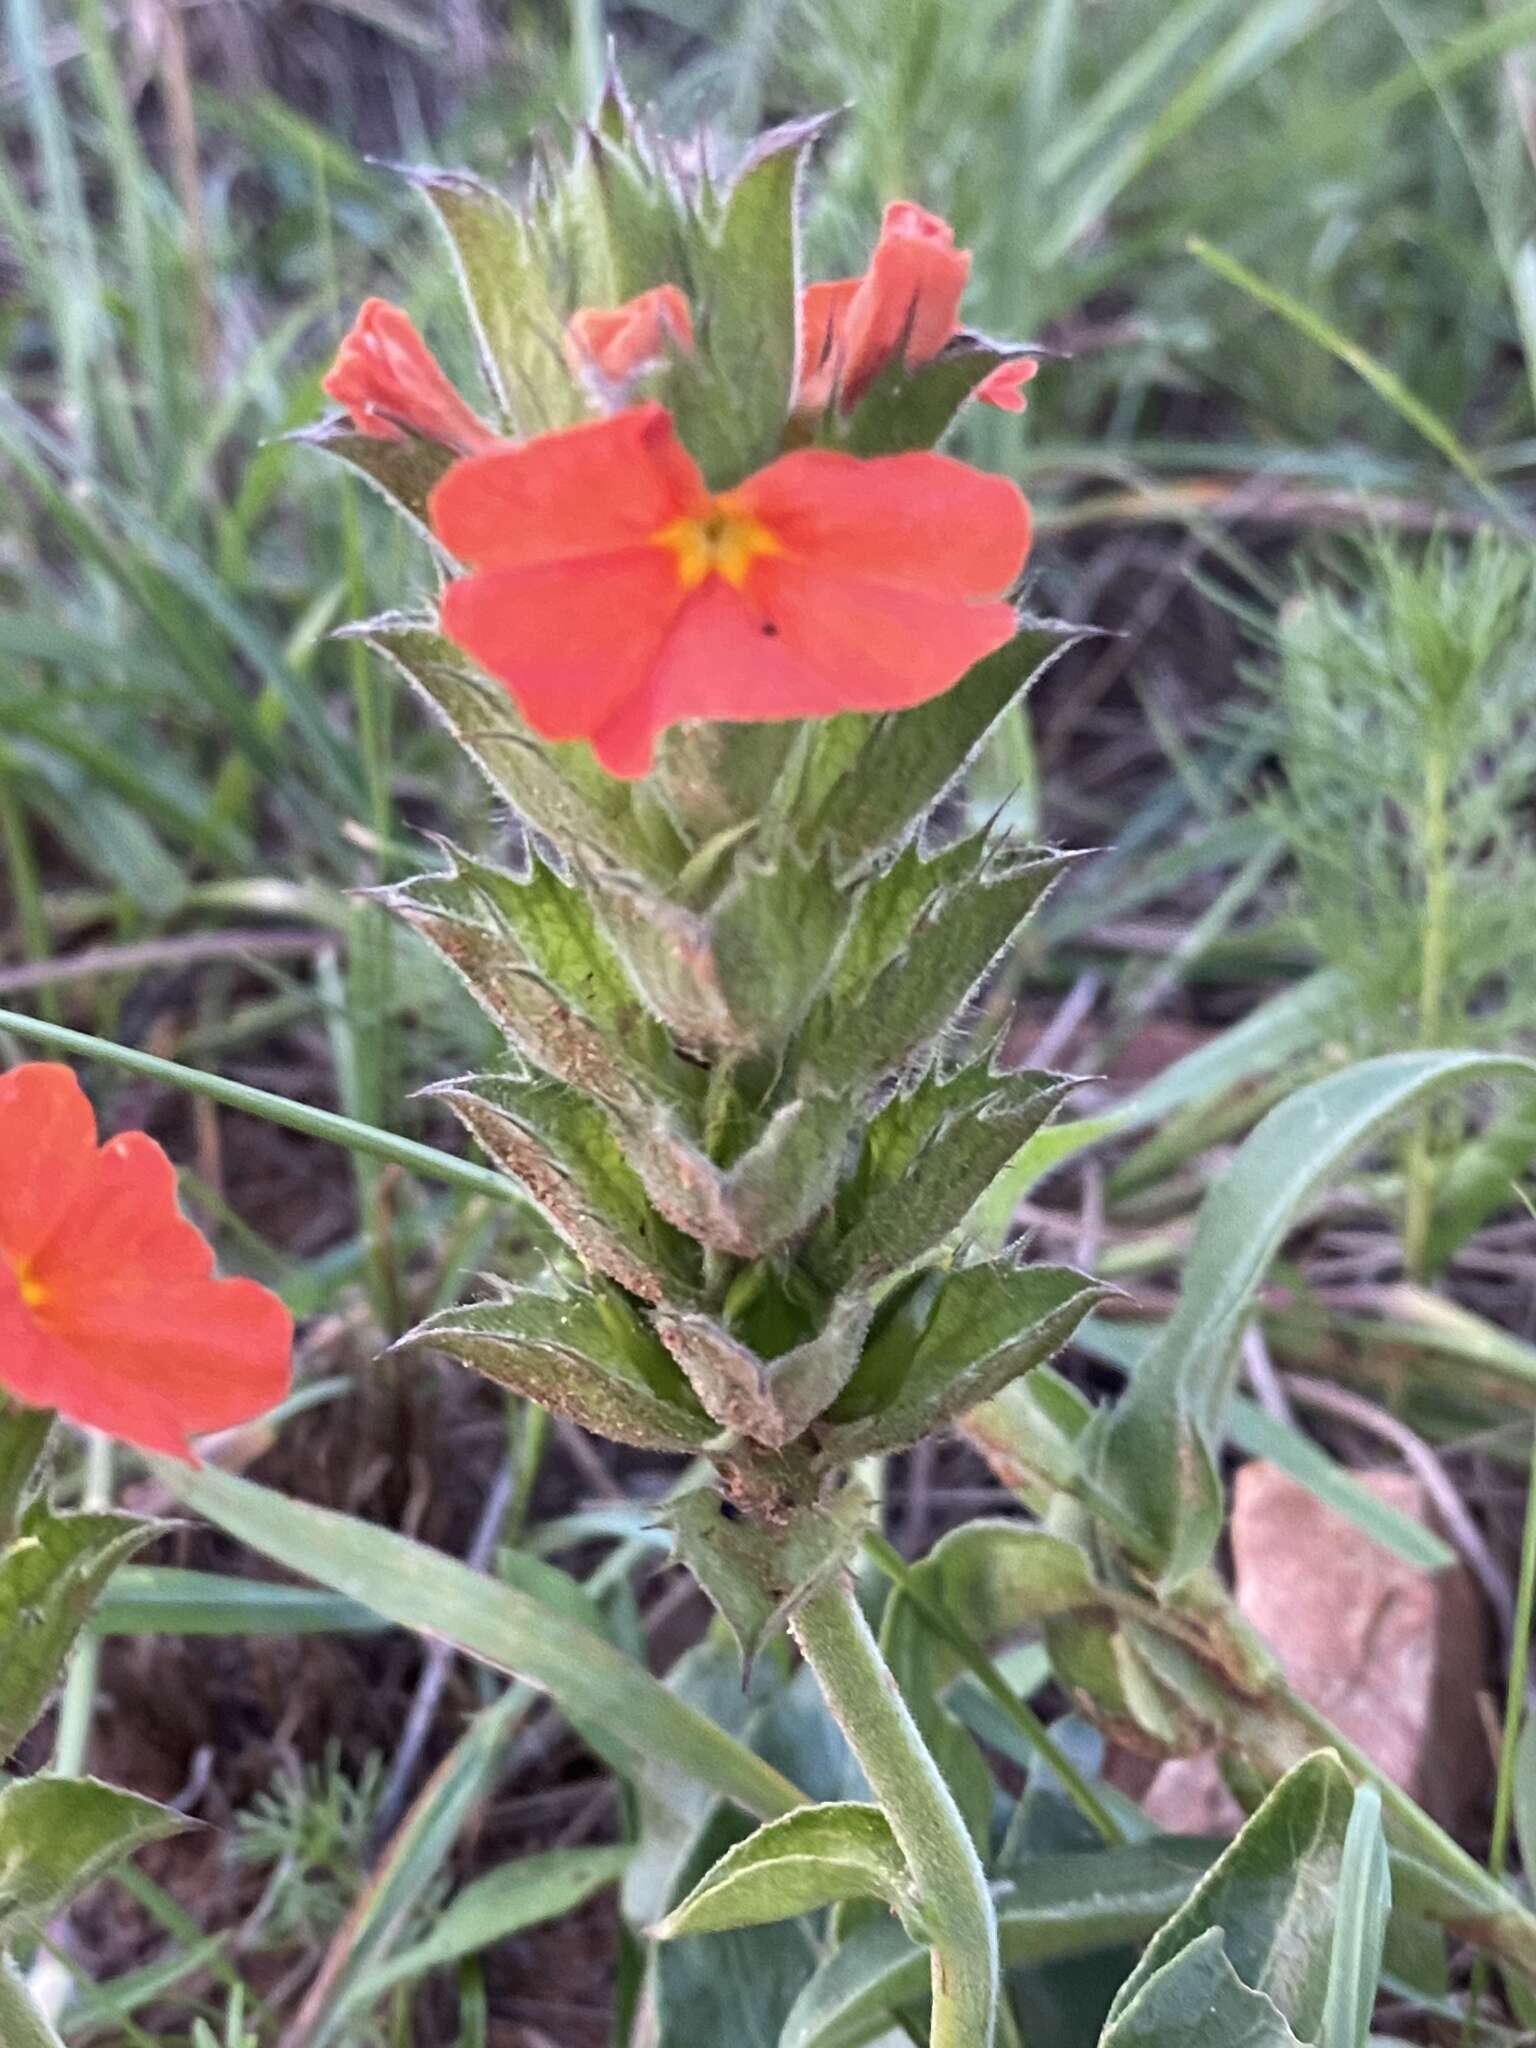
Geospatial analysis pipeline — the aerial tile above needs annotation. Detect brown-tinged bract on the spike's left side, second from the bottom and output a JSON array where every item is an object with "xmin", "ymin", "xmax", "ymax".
[{"xmin": 426, "ymin": 1073, "xmax": 698, "ymax": 1300}]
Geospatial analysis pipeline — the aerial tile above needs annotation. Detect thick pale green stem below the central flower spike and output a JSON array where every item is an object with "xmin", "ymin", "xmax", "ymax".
[{"xmin": 793, "ymin": 1577, "xmax": 997, "ymax": 2048}]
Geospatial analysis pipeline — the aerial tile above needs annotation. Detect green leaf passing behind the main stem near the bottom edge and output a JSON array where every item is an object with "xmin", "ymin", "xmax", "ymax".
[{"xmin": 780, "ymin": 1837, "xmax": 1227, "ymax": 2048}]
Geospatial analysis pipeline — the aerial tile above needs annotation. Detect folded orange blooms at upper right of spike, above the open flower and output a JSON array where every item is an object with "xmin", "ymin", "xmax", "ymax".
[{"xmin": 795, "ymin": 199, "xmax": 1034, "ymax": 412}]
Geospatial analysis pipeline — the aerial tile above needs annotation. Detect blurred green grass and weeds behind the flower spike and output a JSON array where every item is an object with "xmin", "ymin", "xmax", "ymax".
[{"xmin": 0, "ymin": 0, "xmax": 1536, "ymax": 2048}]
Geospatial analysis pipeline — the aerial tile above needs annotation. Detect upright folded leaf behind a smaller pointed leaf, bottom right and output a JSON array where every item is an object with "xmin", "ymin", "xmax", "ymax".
[{"xmin": 1106, "ymin": 1751, "xmax": 1354, "ymax": 2048}]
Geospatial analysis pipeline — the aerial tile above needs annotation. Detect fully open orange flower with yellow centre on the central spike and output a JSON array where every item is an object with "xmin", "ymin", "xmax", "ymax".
[{"xmin": 430, "ymin": 403, "xmax": 1030, "ymax": 776}]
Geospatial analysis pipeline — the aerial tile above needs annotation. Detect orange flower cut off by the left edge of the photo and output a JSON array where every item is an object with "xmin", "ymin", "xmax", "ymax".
[{"xmin": 0, "ymin": 1063, "xmax": 293, "ymax": 1458}]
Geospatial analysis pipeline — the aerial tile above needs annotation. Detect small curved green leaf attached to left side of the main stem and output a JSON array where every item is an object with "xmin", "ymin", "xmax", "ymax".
[{"xmin": 655, "ymin": 1800, "xmax": 918, "ymax": 1942}]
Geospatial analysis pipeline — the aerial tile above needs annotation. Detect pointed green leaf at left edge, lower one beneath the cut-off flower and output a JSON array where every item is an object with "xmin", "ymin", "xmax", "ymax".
[{"xmin": 0, "ymin": 1778, "xmax": 186, "ymax": 1946}]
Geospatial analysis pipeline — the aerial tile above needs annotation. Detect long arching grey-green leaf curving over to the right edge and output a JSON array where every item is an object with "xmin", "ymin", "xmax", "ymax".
[{"xmin": 1092, "ymin": 1053, "xmax": 1536, "ymax": 1589}]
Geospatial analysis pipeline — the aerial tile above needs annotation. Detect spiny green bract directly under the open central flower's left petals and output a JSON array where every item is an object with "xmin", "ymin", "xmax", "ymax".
[{"xmin": 354, "ymin": 612, "xmax": 686, "ymax": 883}]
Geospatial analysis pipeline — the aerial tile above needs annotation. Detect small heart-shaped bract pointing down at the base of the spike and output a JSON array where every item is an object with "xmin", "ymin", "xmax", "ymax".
[{"xmin": 662, "ymin": 1485, "xmax": 872, "ymax": 1671}]
